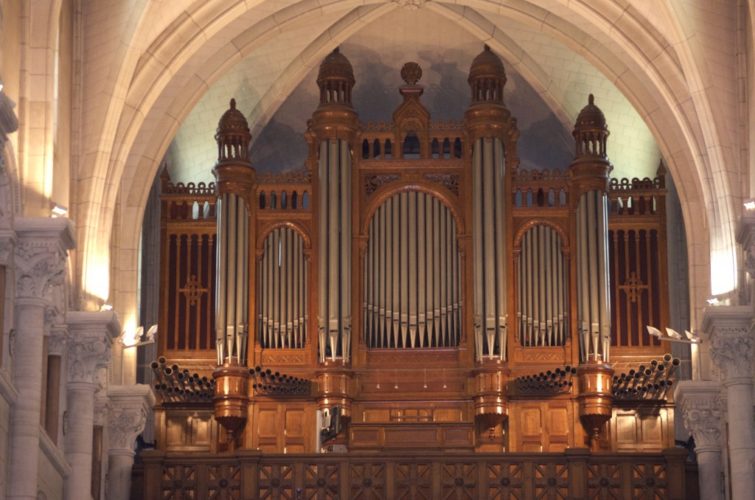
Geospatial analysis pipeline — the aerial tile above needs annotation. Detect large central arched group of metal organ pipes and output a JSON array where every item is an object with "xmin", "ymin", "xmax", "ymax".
[{"xmin": 363, "ymin": 191, "xmax": 461, "ymax": 349}]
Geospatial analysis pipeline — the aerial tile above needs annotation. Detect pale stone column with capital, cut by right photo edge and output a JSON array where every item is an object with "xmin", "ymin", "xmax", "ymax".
[{"xmin": 703, "ymin": 306, "xmax": 755, "ymax": 500}]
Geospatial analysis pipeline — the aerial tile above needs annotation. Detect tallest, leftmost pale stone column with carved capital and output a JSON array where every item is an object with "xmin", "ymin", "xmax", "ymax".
[{"xmin": 8, "ymin": 217, "xmax": 73, "ymax": 499}]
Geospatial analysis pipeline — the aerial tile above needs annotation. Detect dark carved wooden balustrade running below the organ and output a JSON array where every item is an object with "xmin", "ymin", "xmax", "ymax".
[{"xmin": 133, "ymin": 448, "xmax": 694, "ymax": 500}]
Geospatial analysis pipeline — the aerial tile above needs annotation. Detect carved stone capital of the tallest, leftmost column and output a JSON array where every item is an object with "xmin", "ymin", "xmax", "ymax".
[{"xmin": 14, "ymin": 217, "xmax": 74, "ymax": 312}]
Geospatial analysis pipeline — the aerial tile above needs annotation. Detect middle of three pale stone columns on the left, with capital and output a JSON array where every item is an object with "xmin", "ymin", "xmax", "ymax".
[{"xmin": 65, "ymin": 311, "xmax": 119, "ymax": 500}]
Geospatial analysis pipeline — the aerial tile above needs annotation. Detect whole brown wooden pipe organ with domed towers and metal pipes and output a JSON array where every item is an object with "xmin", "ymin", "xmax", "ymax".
[{"xmin": 140, "ymin": 47, "xmax": 692, "ymax": 498}]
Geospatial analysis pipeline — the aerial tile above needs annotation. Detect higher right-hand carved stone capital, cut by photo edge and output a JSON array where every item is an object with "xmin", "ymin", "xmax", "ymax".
[{"xmin": 702, "ymin": 306, "xmax": 753, "ymax": 382}]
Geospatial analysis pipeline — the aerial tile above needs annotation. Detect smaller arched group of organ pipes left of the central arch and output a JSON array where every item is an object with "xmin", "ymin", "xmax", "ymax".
[{"xmin": 257, "ymin": 227, "xmax": 308, "ymax": 349}]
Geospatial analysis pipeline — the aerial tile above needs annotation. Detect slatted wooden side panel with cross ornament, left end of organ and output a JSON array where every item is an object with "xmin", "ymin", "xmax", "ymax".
[{"xmin": 158, "ymin": 182, "xmax": 216, "ymax": 359}]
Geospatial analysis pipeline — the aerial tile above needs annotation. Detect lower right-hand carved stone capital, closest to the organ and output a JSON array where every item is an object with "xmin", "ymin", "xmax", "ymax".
[{"xmin": 674, "ymin": 380, "xmax": 724, "ymax": 451}]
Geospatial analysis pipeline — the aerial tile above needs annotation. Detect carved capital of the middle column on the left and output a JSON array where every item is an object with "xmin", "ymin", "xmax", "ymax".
[{"xmin": 68, "ymin": 311, "xmax": 119, "ymax": 386}]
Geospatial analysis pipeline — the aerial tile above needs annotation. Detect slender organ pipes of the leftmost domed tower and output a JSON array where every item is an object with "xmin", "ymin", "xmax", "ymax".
[{"xmin": 215, "ymin": 193, "xmax": 249, "ymax": 365}]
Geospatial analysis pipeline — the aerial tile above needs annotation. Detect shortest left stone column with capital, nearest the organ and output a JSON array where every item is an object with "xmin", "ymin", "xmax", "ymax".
[{"xmin": 107, "ymin": 385, "xmax": 155, "ymax": 500}]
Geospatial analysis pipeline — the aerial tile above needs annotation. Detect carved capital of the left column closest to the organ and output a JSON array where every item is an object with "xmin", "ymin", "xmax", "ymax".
[{"xmin": 107, "ymin": 384, "xmax": 155, "ymax": 455}]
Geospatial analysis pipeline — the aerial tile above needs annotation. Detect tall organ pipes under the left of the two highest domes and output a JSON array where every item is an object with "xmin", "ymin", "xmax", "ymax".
[{"xmin": 318, "ymin": 139, "xmax": 351, "ymax": 362}]
